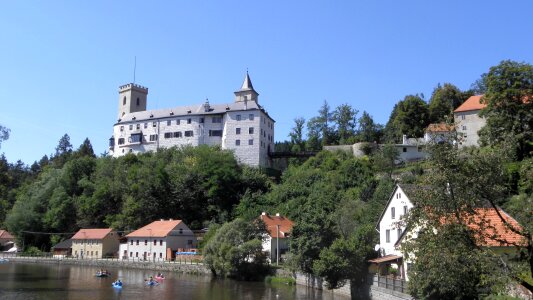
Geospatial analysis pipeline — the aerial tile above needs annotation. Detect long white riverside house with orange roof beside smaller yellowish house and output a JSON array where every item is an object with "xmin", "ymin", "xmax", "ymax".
[{"xmin": 119, "ymin": 219, "xmax": 198, "ymax": 261}]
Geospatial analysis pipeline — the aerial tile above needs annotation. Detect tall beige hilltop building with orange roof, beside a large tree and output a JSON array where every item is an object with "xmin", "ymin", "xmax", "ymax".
[{"xmin": 453, "ymin": 95, "xmax": 487, "ymax": 147}]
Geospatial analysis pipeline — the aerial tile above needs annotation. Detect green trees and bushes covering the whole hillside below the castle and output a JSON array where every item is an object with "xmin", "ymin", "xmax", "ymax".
[{"xmin": 0, "ymin": 61, "xmax": 533, "ymax": 299}]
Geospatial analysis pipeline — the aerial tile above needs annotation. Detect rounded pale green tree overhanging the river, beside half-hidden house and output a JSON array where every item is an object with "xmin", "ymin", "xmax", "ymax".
[{"xmin": 203, "ymin": 219, "xmax": 269, "ymax": 280}]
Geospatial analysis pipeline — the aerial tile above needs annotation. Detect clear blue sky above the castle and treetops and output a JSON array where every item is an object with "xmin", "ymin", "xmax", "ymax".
[{"xmin": 0, "ymin": 0, "xmax": 533, "ymax": 164}]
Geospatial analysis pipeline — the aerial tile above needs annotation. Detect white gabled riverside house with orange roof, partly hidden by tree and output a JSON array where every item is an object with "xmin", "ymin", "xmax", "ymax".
[{"xmin": 370, "ymin": 184, "xmax": 524, "ymax": 280}]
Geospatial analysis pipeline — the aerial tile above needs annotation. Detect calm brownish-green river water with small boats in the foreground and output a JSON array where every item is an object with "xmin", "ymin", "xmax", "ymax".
[{"xmin": 0, "ymin": 262, "xmax": 349, "ymax": 300}]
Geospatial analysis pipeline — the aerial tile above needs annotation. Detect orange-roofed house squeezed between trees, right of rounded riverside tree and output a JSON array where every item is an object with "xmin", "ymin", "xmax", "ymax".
[{"xmin": 260, "ymin": 212, "xmax": 294, "ymax": 262}]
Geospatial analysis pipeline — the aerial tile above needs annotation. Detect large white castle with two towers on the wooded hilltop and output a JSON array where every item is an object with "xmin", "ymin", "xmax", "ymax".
[{"xmin": 109, "ymin": 72, "xmax": 274, "ymax": 167}]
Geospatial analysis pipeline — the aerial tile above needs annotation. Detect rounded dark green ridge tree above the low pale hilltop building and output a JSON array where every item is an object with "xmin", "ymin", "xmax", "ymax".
[{"xmin": 385, "ymin": 95, "xmax": 429, "ymax": 143}]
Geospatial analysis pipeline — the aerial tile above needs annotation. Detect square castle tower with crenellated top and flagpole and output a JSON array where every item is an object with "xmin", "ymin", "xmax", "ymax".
[{"xmin": 118, "ymin": 83, "xmax": 148, "ymax": 119}]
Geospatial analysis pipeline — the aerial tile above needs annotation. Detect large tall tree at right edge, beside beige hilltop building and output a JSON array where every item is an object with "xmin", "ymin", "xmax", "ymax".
[{"xmin": 480, "ymin": 60, "xmax": 533, "ymax": 160}]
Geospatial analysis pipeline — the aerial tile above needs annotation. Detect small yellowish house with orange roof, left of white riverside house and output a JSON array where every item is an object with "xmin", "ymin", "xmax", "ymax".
[{"xmin": 71, "ymin": 228, "xmax": 119, "ymax": 258}]
